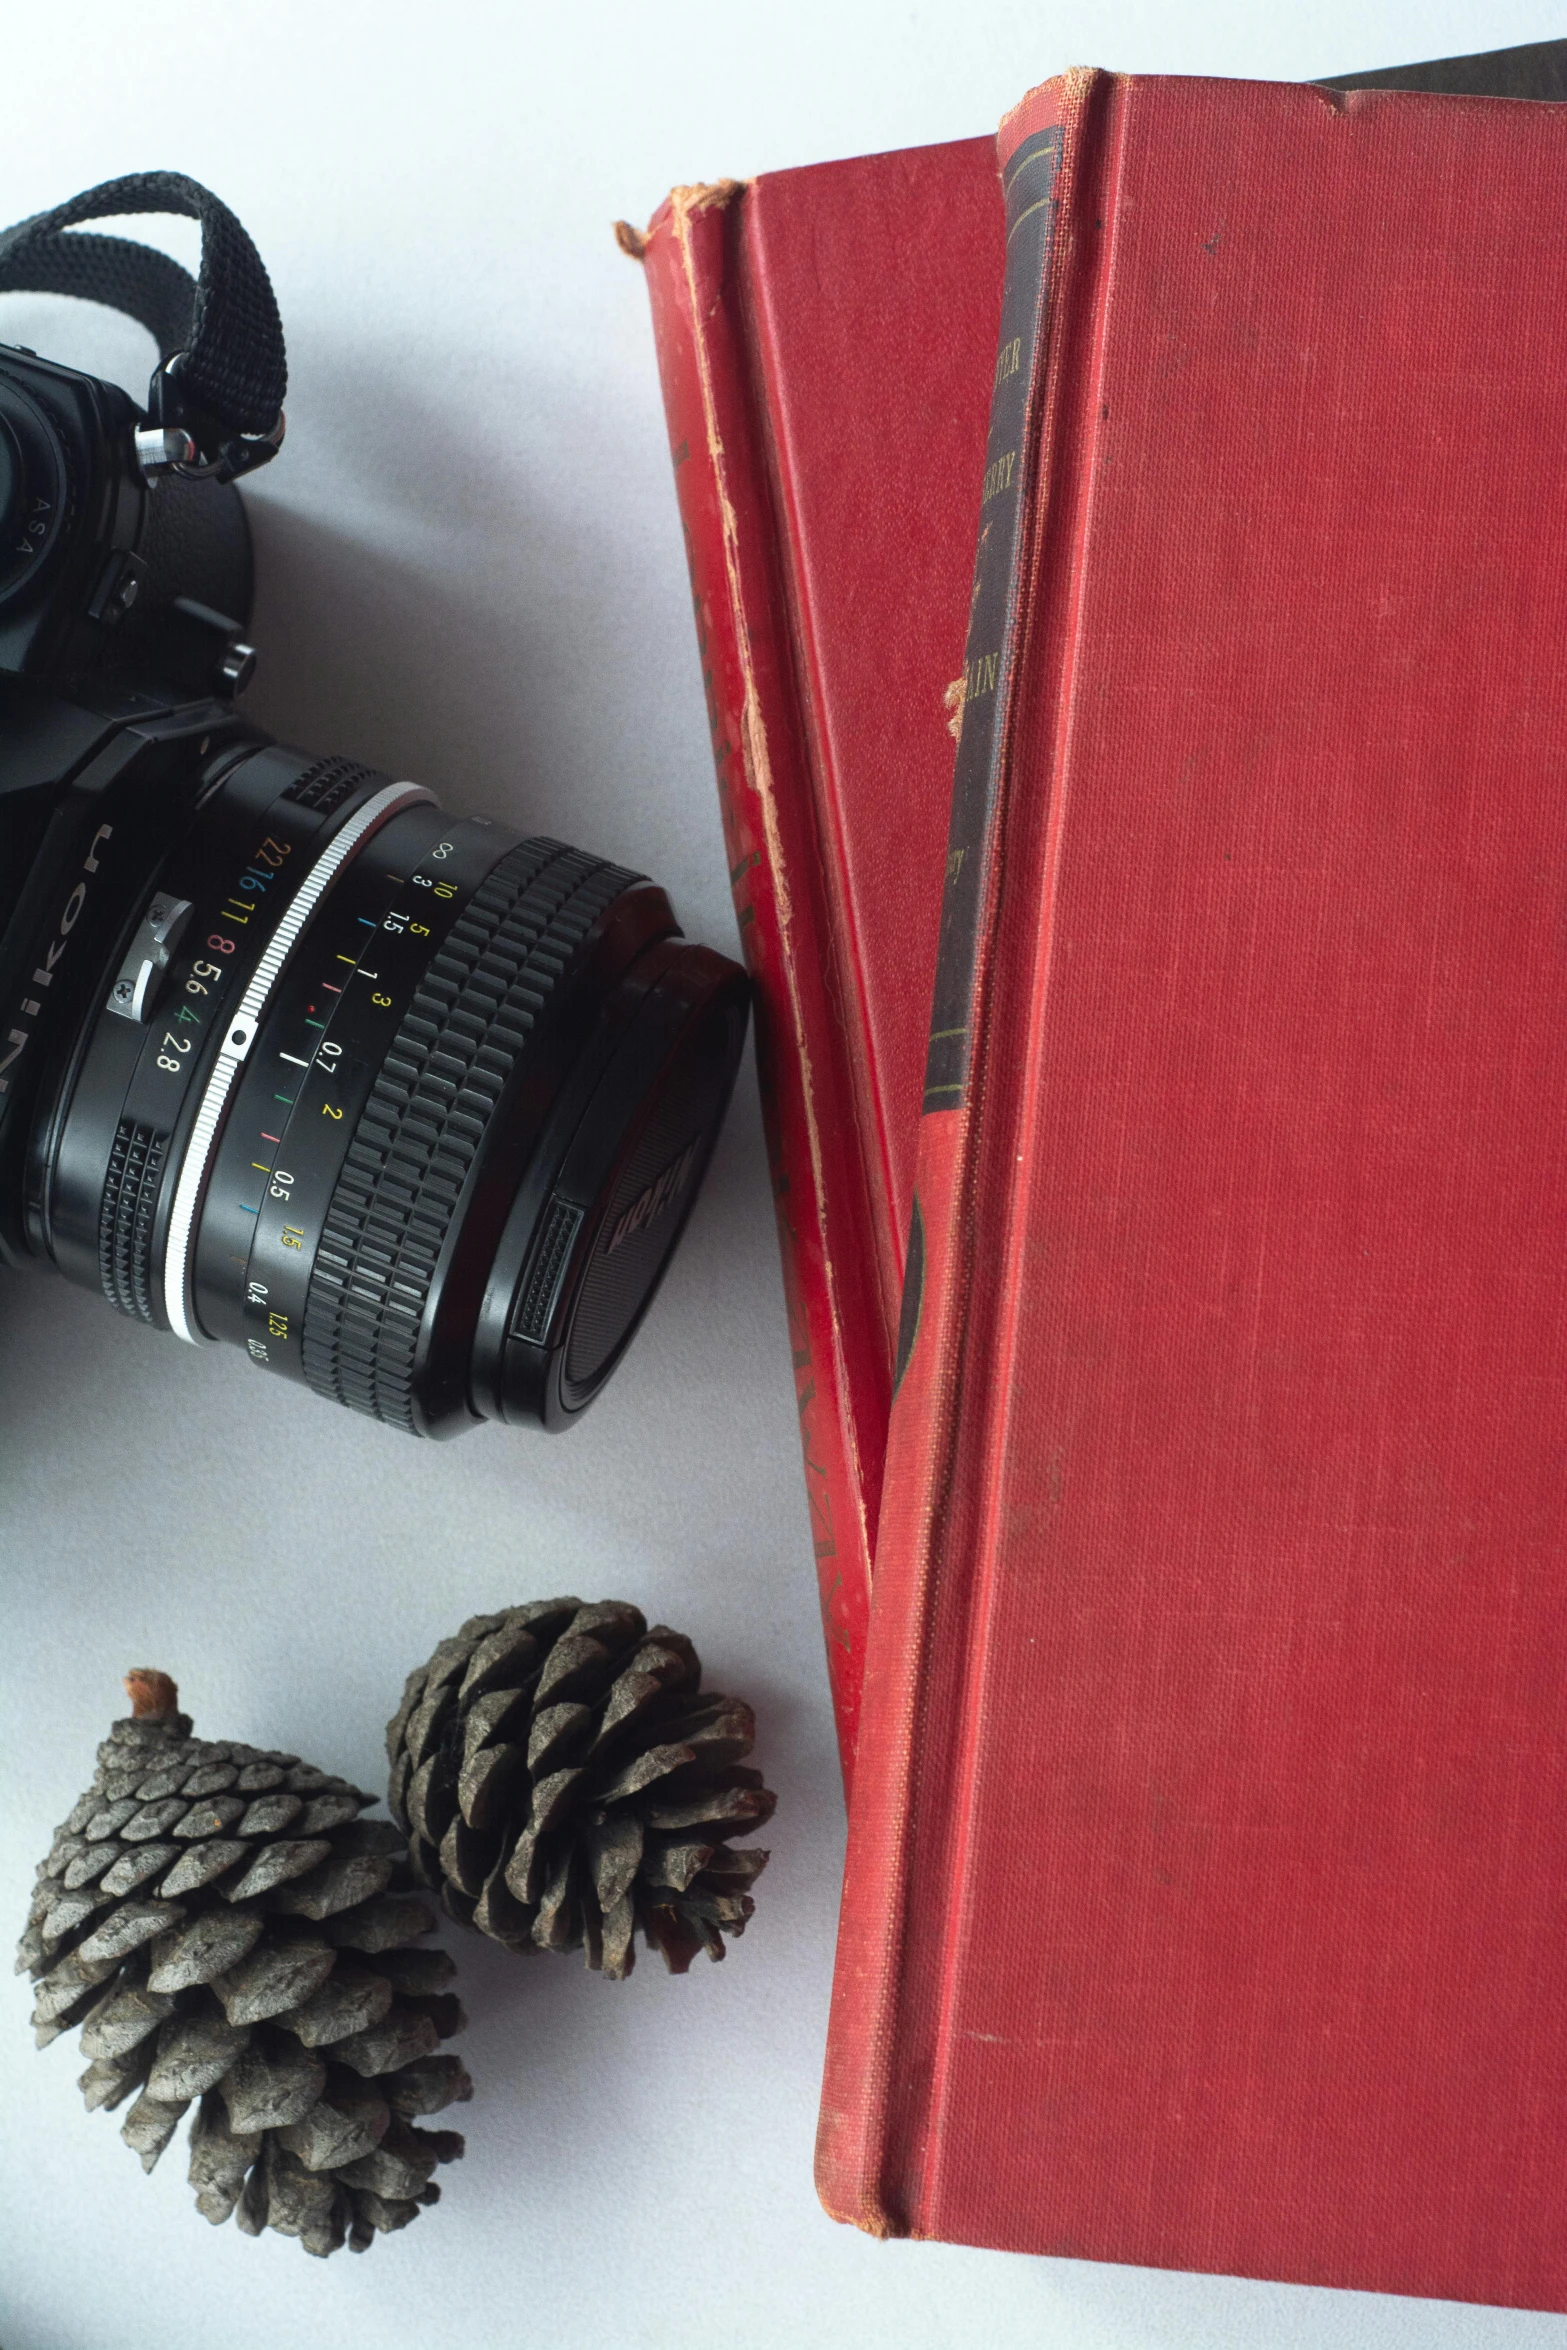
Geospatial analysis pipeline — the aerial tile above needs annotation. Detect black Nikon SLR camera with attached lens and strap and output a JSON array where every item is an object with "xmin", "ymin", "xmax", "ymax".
[{"xmin": 0, "ymin": 172, "xmax": 747, "ymax": 1436}]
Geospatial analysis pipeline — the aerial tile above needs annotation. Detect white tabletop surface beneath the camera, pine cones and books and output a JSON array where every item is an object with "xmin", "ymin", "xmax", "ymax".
[{"xmin": 0, "ymin": 0, "xmax": 1567, "ymax": 2350}]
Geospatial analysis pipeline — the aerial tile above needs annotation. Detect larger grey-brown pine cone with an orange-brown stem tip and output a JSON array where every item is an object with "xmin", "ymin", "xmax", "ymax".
[{"xmin": 16, "ymin": 1673, "xmax": 472, "ymax": 2256}]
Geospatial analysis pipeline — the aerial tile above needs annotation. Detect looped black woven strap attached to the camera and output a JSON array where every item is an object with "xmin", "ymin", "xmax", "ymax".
[{"xmin": 0, "ymin": 172, "xmax": 289, "ymax": 479}]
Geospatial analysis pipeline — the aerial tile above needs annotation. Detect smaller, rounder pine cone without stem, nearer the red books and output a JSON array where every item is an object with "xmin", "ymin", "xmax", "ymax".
[{"xmin": 385, "ymin": 1600, "xmax": 775, "ymax": 1979}]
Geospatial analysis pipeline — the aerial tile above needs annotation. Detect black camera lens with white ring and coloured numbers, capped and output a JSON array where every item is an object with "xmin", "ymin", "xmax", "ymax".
[{"xmin": 33, "ymin": 745, "xmax": 747, "ymax": 1436}]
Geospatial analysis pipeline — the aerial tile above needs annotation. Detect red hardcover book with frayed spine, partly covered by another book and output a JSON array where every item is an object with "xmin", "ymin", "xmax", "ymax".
[{"xmin": 632, "ymin": 139, "xmax": 1003, "ymax": 1777}]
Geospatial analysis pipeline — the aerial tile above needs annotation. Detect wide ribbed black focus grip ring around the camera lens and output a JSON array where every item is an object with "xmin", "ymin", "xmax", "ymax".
[{"xmin": 303, "ymin": 841, "xmax": 639, "ymax": 1429}]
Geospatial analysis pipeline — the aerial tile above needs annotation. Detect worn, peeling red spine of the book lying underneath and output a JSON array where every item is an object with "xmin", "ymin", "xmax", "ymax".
[{"xmin": 641, "ymin": 181, "xmax": 888, "ymax": 1788}]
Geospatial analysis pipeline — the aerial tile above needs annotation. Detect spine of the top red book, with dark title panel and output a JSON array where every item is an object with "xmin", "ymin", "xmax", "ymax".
[{"xmin": 818, "ymin": 71, "xmax": 1109, "ymax": 2235}]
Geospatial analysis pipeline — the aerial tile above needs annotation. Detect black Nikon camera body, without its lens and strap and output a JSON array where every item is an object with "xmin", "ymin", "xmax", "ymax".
[{"xmin": 0, "ymin": 345, "xmax": 268, "ymax": 1264}]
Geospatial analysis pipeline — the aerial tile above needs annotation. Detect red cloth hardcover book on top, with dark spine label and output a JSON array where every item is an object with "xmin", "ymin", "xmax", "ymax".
[{"xmin": 818, "ymin": 73, "xmax": 1567, "ymax": 2310}]
